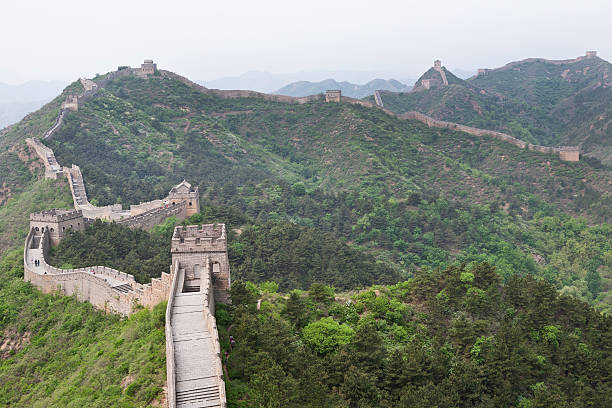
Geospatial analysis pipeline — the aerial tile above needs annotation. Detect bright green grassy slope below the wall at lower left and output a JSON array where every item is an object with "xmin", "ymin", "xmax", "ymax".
[{"xmin": 0, "ymin": 250, "xmax": 166, "ymax": 408}]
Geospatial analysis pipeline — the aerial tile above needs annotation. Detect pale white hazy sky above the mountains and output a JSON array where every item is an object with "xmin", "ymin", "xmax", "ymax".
[{"xmin": 0, "ymin": 0, "xmax": 612, "ymax": 83}]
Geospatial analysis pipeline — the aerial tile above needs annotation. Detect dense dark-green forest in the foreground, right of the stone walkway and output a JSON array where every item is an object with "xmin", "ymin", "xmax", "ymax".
[{"xmin": 217, "ymin": 263, "xmax": 612, "ymax": 408}]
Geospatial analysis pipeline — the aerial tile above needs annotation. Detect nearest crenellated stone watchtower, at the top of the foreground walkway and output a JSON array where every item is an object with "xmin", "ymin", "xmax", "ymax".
[{"xmin": 172, "ymin": 224, "xmax": 231, "ymax": 303}]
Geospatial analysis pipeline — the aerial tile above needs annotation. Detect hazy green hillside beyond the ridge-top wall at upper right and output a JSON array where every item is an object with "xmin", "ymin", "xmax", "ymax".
[{"xmin": 382, "ymin": 57, "xmax": 612, "ymax": 166}]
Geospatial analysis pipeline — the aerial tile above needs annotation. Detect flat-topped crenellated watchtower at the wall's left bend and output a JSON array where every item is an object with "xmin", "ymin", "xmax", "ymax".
[{"xmin": 30, "ymin": 208, "xmax": 85, "ymax": 245}]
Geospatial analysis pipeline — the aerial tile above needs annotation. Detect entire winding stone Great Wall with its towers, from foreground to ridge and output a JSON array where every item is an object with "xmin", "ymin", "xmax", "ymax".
[{"xmin": 24, "ymin": 55, "xmax": 588, "ymax": 408}]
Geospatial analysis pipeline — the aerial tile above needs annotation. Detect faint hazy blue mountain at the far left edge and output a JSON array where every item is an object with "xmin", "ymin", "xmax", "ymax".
[{"xmin": 0, "ymin": 81, "xmax": 67, "ymax": 129}]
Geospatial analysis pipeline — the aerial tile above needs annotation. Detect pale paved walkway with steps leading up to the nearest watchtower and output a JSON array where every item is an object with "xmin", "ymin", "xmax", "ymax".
[{"xmin": 171, "ymin": 292, "xmax": 222, "ymax": 408}]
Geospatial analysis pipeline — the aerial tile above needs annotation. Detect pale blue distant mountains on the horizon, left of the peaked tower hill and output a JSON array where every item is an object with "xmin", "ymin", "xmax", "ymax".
[{"xmin": 274, "ymin": 79, "xmax": 412, "ymax": 99}]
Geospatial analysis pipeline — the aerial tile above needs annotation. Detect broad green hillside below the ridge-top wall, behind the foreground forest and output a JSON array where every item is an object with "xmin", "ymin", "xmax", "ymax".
[{"xmin": 34, "ymin": 71, "xmax": 612, "ymax": 308}]
